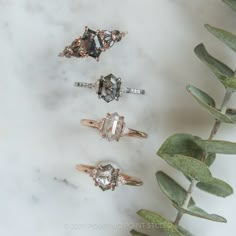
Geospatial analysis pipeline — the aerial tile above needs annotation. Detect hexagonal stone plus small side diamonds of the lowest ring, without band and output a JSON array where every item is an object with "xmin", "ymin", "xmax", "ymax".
[{"xmin": 90, "ymin": 164, "xmax": 121, "ymax": 191}]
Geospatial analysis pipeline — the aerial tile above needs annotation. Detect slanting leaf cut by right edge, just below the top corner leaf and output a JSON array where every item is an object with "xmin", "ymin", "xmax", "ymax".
[{"xmin": 205, "ymin": 24, "xmax": 236, "ymax": 52}]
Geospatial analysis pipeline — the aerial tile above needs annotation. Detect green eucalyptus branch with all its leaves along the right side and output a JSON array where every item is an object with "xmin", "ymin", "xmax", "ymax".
[{"xmin": 131, "ymin": 0, "xmax": 236, "ymax": 236}]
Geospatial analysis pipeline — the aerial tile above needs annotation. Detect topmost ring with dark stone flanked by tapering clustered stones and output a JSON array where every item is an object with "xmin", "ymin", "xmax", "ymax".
[{"xmin": 59, "ymin": 27, "xmax": 126, "ymax": 61}]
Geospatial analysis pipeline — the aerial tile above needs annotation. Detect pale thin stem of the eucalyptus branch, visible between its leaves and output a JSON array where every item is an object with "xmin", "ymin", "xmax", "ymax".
[{"xmin": 174, "ymin": 89, "xmax": 232, "ymax": 225}]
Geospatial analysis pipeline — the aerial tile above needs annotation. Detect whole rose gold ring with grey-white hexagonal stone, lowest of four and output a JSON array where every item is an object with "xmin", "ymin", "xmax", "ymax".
[{"xmin": 76, "ymin": 164, "xmax": 143, "ymax": 191}]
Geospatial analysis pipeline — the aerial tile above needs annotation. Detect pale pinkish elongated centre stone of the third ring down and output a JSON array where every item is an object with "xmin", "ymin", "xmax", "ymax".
[{"xmin": 102, "ymin": 112, "xmax": 124, "ymax": 141}]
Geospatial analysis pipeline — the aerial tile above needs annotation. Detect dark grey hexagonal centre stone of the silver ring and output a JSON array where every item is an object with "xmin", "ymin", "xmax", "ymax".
[{"xmin": 97, "ymin": 74, "xmax": 121, "ymax": 102}]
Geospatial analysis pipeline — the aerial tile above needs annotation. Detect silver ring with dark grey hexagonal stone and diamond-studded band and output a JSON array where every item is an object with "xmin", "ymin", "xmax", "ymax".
[{"xmin": 74, "ymin": 74, "xmax": 145, "ymax": 102}]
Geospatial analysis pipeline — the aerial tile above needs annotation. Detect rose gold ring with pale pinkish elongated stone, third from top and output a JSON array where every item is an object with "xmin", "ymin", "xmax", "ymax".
[{"xmin": 80, "ymin": 112, "xmax": 148, "ymax": 141}]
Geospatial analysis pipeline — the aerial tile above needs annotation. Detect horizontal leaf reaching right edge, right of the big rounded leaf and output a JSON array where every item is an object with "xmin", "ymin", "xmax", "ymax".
[{"xmin": 196, "ymin": 140, "xmax": 236, "ymax": 154}]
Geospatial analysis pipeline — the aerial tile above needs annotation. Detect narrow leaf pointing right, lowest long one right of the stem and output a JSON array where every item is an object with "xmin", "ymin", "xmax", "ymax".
[{"xmin": 173, "ymin": 204, "xmax": 227, "ymax": 223}]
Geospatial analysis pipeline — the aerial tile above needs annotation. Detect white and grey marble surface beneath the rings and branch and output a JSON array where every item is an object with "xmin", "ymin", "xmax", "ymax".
[{"xmin": 0, "ymin": 0, "xmax": 236, "ymax": 236}]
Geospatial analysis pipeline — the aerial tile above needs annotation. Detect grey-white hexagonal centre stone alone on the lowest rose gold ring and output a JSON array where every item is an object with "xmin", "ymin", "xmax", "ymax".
[{"xmin": 94, "ymin": 164, "xmax": 118, "ymax": 191}]
